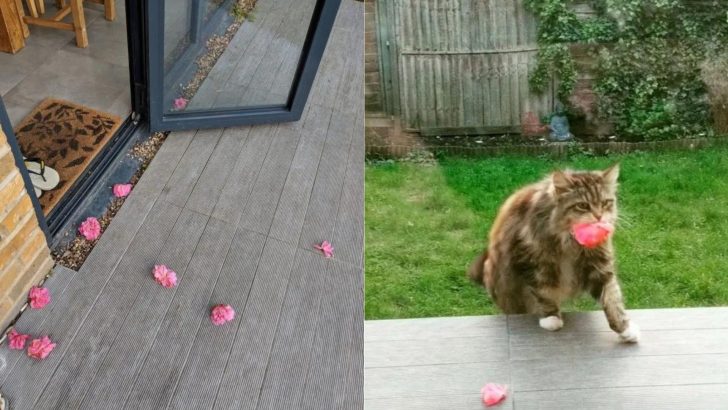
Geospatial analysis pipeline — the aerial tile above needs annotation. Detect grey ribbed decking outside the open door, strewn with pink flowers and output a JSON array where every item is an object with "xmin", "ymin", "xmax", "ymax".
[{"xmin": 0, "ymin": 0, "xmax": 364, "ymax": 410}]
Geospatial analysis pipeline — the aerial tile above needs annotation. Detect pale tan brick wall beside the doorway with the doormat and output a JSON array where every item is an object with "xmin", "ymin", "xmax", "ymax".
[{"xmin": 0, "ymin": 129, "xmax": 53, "ymax": 331}]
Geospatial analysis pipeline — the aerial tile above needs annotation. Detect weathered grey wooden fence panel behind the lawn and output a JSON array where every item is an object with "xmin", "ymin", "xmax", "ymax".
[{"xmin": 377, "ymin": 0, "xmax": 554, "ymax": 135}]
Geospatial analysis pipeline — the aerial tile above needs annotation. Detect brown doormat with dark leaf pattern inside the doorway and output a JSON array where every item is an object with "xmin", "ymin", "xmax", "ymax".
[{"xmin": 15, "ymin": 98, "xmax": 121, "ymax": 215}]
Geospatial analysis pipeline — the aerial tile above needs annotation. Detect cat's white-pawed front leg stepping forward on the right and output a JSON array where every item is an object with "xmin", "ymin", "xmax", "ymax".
[{"xmin": 591, "ymin": 273, "xmax": 640, "ymax": 343}]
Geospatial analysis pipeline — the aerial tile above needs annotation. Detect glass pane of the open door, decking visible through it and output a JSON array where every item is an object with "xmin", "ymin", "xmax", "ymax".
[{"xmin": 164, "ymin": 0, "xmax": 317, "ymax": 113}]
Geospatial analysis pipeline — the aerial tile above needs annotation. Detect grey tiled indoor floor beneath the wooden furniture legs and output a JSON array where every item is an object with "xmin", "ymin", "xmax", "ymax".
[{"xmin": 0, "ymin": 1, "xmax": 131, "ymax": 126}]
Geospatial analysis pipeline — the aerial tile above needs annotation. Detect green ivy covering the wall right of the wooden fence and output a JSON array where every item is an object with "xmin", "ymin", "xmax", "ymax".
[{"xmin": 526, "ymin": 0, "xmax": 728, "ymax": 140}]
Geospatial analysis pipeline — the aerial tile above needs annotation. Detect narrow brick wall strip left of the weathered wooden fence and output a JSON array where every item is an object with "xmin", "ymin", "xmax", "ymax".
[{"xmin": 364, "ymin": 0, "xmax": 382, "ymax": 113}]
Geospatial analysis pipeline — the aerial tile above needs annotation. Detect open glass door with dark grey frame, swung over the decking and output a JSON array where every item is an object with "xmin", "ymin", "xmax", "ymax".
[{"xmin": 147, "ymin": 0, "xmax": 341, "ymax": 131}]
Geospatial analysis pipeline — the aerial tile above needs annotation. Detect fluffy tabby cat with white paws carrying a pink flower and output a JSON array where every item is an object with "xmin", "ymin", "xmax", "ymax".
[{"xmin": 469, "ymin": 165, "xmax": 639, "ymax": 342}]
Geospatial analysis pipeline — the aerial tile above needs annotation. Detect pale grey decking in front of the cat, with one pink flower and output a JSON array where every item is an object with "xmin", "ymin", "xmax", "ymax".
[{"xmin": 364, "ymin": 308, "xmax": 728, "ymax": 410}]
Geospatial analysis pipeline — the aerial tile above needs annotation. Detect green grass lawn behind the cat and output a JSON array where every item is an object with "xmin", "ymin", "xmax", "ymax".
[{"xmin": 365, "ymin": 148, "xmax": 728, "ymax": 319}]
